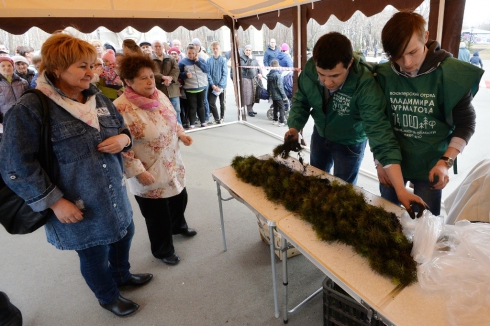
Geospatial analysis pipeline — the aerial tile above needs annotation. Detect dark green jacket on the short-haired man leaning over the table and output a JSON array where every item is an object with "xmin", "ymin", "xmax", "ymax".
[{"xmin": 288, "ymin": 55, "xmax": 401, "ymax": 165}]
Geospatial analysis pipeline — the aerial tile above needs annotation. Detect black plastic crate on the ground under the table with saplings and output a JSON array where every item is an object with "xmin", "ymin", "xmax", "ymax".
[{"xmin": 323, "ymin": 277, "xmax": 385, "ymax": 326}]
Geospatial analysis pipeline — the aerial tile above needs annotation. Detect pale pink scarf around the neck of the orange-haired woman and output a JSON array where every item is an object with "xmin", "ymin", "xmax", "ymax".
[{"xmin": 36, "ymin": 72, "xmax": 100, "ymax": 131}]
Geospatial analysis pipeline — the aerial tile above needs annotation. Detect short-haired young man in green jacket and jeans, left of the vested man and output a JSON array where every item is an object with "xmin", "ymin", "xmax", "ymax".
[{"xmin": 285, "ymin": 32, "xmax": 401, "ymax": 184}]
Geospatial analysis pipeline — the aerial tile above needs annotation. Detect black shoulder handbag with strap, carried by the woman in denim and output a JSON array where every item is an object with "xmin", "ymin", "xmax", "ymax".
[{"xmin": 0, "ymin": 89, "xmax": 54, "ymax": 234}]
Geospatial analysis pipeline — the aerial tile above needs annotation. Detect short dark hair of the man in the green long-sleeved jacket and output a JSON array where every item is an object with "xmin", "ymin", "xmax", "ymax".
[{"xmin": 313, "ymin": 32, "xmax": 352, "ymax": 70}]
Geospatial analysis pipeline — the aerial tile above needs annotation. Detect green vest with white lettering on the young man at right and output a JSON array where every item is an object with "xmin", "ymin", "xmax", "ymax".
[{"xmin": 377, "ymin": 57, "xmax": 483, "ymax": 181}]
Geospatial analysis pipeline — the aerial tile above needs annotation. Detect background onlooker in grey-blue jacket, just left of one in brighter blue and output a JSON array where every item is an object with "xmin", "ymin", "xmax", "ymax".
[{"xmin": 179, "ymin": 44, "xmax": 209, "ymax": 129}]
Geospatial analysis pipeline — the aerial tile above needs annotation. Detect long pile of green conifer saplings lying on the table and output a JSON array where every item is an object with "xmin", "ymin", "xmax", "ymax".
[{"xmin": 231, "ymin": 140, "xmax": 417, "ymax": 285}]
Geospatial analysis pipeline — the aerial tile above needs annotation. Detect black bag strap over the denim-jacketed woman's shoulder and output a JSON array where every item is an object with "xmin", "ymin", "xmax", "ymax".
[{"xmin": 22, "ymin": 89, "xmax": 55, "ymax": 183}]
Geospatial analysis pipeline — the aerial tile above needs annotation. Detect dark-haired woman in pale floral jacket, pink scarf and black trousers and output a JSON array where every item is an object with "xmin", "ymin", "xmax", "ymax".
[{"xmin": 114, "ymin": 55, "xmax": 197, "ymax": 265}]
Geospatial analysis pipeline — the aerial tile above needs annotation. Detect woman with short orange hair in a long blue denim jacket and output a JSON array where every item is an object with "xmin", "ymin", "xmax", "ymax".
[{"xmin": 0, "ymin": 33, "xmax": 153, "ymax": 316}]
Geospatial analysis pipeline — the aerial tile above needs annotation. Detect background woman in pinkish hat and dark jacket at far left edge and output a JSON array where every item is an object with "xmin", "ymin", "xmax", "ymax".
[{"xmin": 0, "ymin": 57, "xmax": 29, "ymax": 119}]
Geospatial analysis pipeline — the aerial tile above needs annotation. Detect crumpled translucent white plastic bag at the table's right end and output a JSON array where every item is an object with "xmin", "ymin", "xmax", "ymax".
[{"xmin": 409, "ymin": 213, "xmax": 490, "ymax": 325}]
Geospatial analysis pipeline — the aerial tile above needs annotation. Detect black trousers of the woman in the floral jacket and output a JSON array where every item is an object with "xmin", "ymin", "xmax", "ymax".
[{"xmin": 134, "ymin": 188, "xmax": 187, "ymax": 259}]
